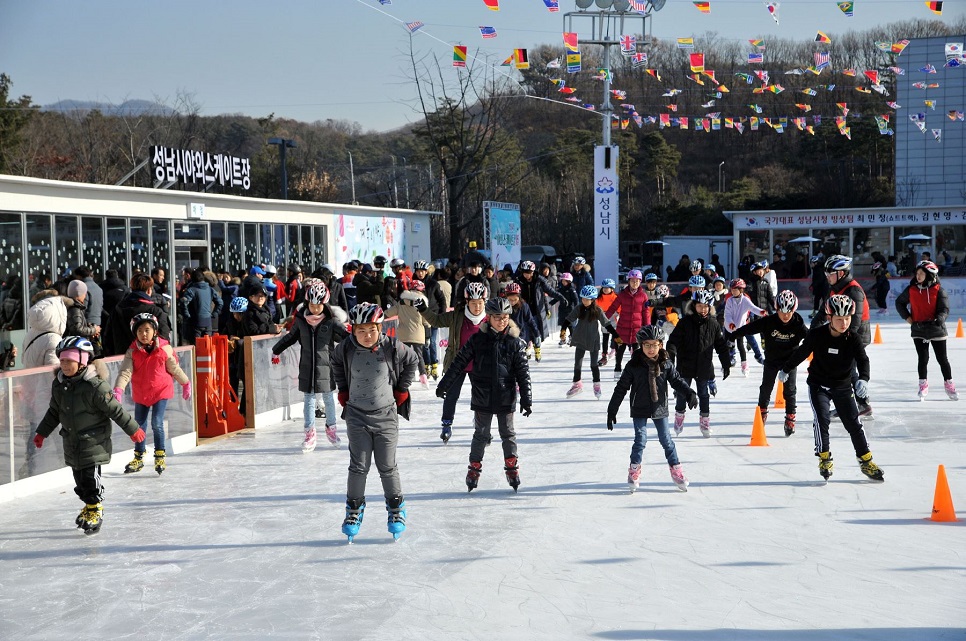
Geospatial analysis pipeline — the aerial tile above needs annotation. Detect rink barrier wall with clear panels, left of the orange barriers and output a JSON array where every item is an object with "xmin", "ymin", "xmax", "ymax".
[{"xmin": 0, "ymin": 347, "xmax": 198, "ymax": 502}]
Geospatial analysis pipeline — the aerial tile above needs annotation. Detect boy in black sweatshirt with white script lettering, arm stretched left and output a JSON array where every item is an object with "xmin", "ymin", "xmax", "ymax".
[{"xmin": 725, "ymin": 289, "xmax": 808, "ymax": 436}]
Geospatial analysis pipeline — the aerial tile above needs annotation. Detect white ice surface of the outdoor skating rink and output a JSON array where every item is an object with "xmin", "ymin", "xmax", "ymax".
[{"xmin": 0, "ymin": 312, "xmax": 966, "ymax": 641}]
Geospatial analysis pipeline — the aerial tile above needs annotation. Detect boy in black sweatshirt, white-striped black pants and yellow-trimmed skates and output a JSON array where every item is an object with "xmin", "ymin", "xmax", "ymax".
[{"xmin": 778, "ymin": 294, "xmax": 883, "ymax": 481}]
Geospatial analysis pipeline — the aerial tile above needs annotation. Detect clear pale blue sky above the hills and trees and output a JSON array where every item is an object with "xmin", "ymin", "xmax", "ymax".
[{"xmin": 0, "ymin": 0, "xmax": 966, "ymax": 130}]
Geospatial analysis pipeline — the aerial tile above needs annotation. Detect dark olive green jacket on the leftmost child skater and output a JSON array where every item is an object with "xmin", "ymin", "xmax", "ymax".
[{"xmin": 37, "ymin": 365, "xmax": 138, "ymax": 469}]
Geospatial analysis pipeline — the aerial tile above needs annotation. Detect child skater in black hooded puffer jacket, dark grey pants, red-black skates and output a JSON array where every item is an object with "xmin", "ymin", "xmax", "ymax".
[{"xmin": 436, "ymin": 298, "xmax": 532, "ymax": 492}]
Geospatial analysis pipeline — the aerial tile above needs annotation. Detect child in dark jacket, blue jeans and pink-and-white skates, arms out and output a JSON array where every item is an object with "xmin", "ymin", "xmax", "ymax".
[{"xmin": 607, "ymin": 325, "xmax": 698, "ymax": 492}]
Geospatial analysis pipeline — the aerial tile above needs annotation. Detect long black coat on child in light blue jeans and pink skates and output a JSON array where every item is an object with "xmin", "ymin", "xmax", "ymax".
[{"xmin": 272, "ymin": 305, "xmax": 349, "ymax": 394}]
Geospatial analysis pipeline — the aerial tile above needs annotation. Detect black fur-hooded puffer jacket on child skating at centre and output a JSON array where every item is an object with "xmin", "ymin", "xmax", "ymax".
[{"xmin": 438, "ymin": 322, "xmax": 533, "ymax": 414}]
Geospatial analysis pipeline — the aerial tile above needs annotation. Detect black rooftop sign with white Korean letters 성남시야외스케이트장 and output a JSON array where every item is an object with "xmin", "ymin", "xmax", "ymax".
[{"xmin": 151, "ymin": 146, "xmax": 252, "ymax": 190}]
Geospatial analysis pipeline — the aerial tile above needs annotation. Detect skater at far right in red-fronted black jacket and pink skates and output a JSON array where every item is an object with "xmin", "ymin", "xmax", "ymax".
[{"xmin": 896, "ymin": 260, "xmax": 959, "ymax": 401}]
